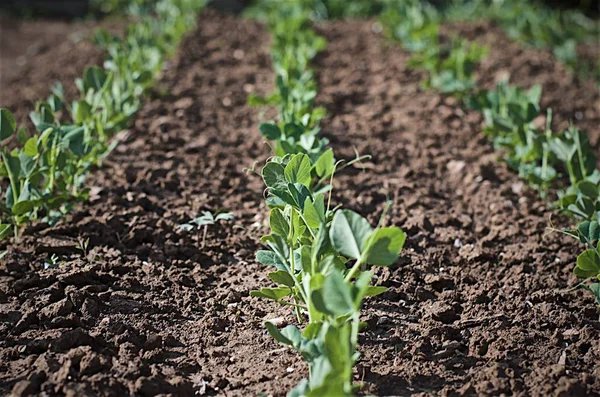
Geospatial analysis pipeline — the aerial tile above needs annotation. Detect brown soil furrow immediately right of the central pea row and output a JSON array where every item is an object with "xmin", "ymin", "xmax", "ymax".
[{"xmin": 317, "ymin": 22, "xmax": 600, "ymax": 395}]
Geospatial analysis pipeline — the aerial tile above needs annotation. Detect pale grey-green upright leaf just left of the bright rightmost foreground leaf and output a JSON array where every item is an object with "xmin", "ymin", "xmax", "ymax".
[{"xmin": 329, "ymin": 210, "xmax": 373, "ymax": 259}]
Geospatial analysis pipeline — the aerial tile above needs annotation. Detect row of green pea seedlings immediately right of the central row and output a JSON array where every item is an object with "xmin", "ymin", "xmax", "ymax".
[{"xmin": 382, "ymin": 0, "xmax": 600, "ymax": 304}]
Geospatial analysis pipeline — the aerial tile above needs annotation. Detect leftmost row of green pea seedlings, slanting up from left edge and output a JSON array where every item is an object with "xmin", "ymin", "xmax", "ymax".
[{"xmin": 0, "ymin": 0, "xmax": 203, "ymax": 240}]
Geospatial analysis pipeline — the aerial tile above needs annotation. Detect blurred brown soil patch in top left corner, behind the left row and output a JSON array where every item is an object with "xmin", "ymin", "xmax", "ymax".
[{"xmin": 0, "ymin": 16, "xmax": 125, "ymax": 122}]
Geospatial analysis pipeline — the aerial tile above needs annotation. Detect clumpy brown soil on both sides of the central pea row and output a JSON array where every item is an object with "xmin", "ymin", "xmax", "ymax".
[{"xmin": 0, "ymin": 11, "xmax": 600, "ymax": 396}]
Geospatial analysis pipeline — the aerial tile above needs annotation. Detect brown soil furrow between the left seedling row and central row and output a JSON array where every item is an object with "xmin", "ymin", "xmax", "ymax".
[{"xmin": 0, "ymin": 11, "xmax": 304, "ymax": 396}]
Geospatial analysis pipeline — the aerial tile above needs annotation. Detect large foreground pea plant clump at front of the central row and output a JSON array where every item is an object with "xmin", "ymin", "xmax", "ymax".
[{"xmin": 251, "ymin": 154, "xmax": 406, "ymax": 396}]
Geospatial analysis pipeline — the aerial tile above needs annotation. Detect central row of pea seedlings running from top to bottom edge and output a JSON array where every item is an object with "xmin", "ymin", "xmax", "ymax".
[{"xmin": 250, "ymin": 2, "xmax": 406, "ymax": 397}]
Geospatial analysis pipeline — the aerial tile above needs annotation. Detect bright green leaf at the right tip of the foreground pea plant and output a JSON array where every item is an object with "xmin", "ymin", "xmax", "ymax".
[{"xmin": 365, "ymin": 227, "xmax": 406, "ymax": 266}]
